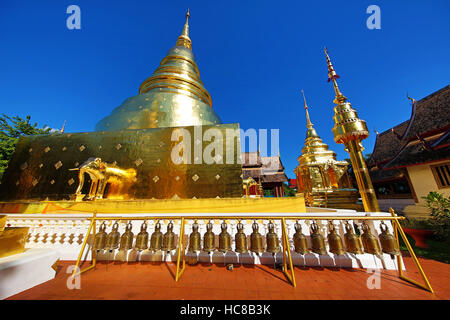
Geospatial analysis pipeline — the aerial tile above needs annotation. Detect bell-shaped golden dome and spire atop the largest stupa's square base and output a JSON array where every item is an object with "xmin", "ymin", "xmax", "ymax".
[{"xmin": 95, "ymin": 10, "xmax": 222, "ymax": 131}]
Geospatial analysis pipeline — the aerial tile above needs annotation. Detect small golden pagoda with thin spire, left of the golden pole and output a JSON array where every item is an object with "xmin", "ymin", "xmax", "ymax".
[{"xmin": 294, "ymin": 90, "xmax": 361, "ymax": 209}]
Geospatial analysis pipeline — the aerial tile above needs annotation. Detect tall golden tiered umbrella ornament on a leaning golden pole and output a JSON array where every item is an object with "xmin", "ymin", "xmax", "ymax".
[{"xmin": 325, "ymin": 48, "xmax": 380, "ymax": 212}]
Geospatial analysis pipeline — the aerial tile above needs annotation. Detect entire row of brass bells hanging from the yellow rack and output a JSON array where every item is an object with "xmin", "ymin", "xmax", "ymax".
[{"xmin": 94, "ymin": 221, "xmax": 400, "ymax": 255}]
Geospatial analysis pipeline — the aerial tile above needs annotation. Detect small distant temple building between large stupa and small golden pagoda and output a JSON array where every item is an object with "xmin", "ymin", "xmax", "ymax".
[{"xmin": 241, "ymin": 151, "xmax": 288, "ymax": 197}]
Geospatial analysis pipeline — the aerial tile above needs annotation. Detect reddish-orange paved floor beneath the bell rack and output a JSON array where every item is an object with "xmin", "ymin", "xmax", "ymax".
[{"xmin": 9, "ymin": 258, "xmax": 450, "ymax": 300}]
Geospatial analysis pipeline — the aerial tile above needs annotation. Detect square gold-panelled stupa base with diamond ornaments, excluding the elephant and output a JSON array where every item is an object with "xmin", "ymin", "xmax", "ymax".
[{"xmin": 0, "ymin": 124, "xmax": 243, "ymax": 201}]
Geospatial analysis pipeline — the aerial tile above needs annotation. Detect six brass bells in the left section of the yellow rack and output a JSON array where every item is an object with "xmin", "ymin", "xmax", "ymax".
[{"xmin": 93, "ymin": 221, "xmax": 176, "ymax": 251}]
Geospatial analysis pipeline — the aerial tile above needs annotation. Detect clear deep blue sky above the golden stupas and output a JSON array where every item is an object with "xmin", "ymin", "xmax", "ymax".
[{"xmin": 0, "ymin": 0, "xmax": 450, "ymax": 177}]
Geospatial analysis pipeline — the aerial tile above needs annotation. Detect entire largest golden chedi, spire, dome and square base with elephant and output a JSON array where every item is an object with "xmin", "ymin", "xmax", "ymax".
[{"xmin": 0, "ymin": 12, "xmax": 243, "ymax": 205}]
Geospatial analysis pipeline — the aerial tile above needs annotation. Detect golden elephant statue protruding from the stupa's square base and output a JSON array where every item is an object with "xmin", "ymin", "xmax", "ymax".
[{"xmin": 69, "ymin": 158, "xmax": 136, "ymax": 200}]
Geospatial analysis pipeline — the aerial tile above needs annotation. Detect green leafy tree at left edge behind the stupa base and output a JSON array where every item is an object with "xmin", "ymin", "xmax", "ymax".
[{"xmin": 0, "ymin": 114, "xmax": 51, "ymax": 178}]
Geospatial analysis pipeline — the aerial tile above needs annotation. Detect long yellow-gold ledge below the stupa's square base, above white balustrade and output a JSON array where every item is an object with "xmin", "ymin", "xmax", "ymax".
[{"xmin": 0, "ymin": 195, "xmax": 306, "ymax": 214}]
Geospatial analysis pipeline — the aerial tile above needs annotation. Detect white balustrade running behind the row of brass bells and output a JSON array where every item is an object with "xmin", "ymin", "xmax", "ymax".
[{"xmin": 3, "ymin": 210, "xmax": 404, "ymax": 269}]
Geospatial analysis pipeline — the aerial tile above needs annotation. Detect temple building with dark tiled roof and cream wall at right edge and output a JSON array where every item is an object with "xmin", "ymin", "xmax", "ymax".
[{"xmin": 369, "ymin": 85, "xmax": 450, "ymax": 216}]
